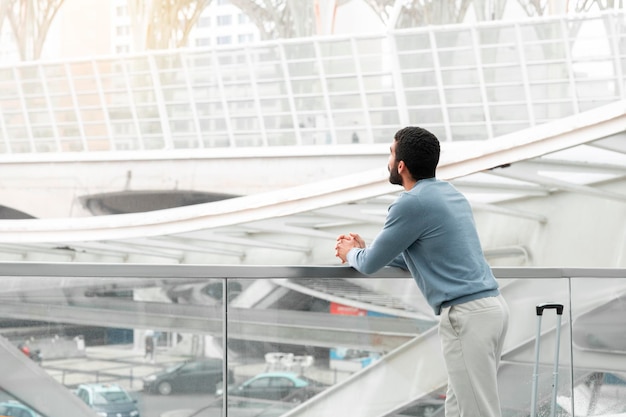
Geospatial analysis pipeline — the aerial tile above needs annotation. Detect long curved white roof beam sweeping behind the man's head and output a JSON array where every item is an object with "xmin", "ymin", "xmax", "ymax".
[{"xmin": 0, "ymin": 101, "xmax": 626, "ymax": 243}]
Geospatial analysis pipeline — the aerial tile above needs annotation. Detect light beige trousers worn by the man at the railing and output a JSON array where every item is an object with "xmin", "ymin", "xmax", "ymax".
[{"xmin": 439, "ymin": 295, "xmax": 509, "ymax": 417}]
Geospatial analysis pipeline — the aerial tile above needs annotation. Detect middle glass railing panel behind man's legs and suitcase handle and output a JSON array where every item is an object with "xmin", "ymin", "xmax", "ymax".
[{"xmin": 222, "ymin": 277, "xmax": 571, "ymax": 416}]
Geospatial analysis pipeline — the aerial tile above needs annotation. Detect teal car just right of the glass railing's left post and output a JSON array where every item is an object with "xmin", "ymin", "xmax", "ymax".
[{"xmin": 217, "ymin": 372, "xmax": 328, "ymax": 403}]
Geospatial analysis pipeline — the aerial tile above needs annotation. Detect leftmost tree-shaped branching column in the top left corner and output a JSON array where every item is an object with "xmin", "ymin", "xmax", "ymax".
[{"xmin": 6, "ymin": 0, "xmax": 64, "ymax": 60}]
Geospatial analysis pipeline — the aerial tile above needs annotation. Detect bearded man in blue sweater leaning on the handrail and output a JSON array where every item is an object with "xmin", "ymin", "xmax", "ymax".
[{"xmin": 335, "ymin": 127, "xmax": 508, "ymax": 417}]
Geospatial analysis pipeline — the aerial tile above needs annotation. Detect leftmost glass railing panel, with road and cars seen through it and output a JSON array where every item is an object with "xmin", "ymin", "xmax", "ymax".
[{"xmin": 0, "ymin": 277, "xmax": 225, "ymax": 417}]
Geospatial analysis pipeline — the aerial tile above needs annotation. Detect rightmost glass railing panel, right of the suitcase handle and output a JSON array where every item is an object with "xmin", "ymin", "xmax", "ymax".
[{"xmin": 562, "ymin": 275, "xmax": 626, "ymax": 416}]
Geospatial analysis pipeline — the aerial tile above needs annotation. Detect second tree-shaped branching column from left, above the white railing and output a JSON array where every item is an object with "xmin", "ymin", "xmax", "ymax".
[{"xmin": 127, "ymin": 0, "xmax": 211, "ymax": 51}]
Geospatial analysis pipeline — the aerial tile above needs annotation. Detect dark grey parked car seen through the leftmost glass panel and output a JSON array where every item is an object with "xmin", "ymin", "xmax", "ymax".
[{"xmin": 143, "ymin": 358, "xmax": 233, "ymax": 395}]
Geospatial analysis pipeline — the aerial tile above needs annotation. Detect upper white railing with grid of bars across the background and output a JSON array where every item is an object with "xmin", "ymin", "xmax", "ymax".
[{"xmin": 0, "ymin": 10, "xmax": 626, "ymax": 153}]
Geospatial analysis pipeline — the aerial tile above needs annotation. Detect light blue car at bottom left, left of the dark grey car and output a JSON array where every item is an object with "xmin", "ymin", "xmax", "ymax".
[{"xmin": 76, "ymin": 384, "xmax": 139, "ymax": 417}]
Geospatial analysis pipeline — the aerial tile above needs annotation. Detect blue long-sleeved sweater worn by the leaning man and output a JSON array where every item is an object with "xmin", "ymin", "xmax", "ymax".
[{"xmin": 347, "ymin": 178, "xmax": 499, "ymax": 315}]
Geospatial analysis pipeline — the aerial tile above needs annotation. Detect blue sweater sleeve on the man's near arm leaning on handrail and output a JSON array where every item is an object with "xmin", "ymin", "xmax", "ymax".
[{"xmin": 347, "ymin": 195, "xmax": 419, "ymax": 274}]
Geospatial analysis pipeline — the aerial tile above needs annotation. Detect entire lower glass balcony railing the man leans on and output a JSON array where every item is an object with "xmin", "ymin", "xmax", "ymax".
[{"xmin": 0, "ymin": 263, "xmax": 626, "ymax": 417}]
